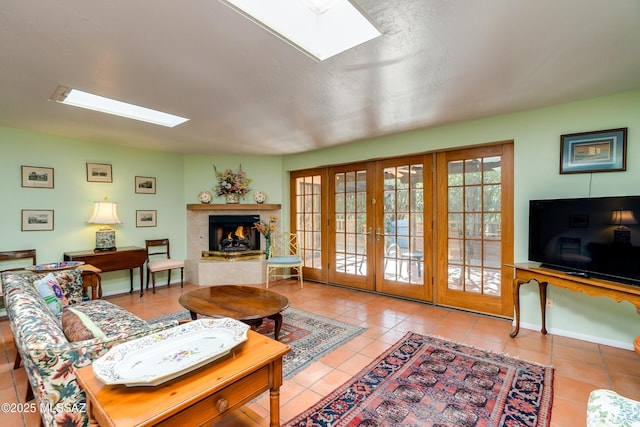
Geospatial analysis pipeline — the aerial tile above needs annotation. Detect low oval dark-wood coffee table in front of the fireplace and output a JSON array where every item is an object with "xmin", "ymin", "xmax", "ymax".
[{"xmin": 179, "ymin": 285, "xmax": 289, "ymax": 341}]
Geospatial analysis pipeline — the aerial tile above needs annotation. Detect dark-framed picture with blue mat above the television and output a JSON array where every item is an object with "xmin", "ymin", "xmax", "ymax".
[{"xmin": 560, "ymin": 128, "xmax": 627, "ymax": 174}]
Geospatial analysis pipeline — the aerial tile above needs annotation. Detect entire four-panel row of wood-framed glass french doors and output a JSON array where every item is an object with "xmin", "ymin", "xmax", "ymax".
[{"xmin": 291, "ymin": 144, "xmax": 513, "ymax": 315}]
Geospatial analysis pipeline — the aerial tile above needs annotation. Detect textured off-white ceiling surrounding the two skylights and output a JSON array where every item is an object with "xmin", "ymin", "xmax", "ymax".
[{"xmin": 0, "ymin": 0, "xmax": 640, "ymax": 154}]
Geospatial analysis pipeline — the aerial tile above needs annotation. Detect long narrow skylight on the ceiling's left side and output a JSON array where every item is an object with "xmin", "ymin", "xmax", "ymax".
[{"xmin": 51, "ymin": 86, "xmax": 189, "ymax": 127}]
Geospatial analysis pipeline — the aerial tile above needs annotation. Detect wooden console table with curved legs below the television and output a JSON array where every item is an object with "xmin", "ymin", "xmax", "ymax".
[{"xmin": 507, "ymin": 263, "xmax": 640, "ymax": 338}]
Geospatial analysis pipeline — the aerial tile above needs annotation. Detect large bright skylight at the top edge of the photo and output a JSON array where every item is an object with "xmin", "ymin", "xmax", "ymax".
[{"xmin": 221, "ymin": 0, "xmax": 381, "ymax": 61}]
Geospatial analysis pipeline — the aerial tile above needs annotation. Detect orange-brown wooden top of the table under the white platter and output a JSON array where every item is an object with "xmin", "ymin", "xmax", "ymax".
[{"xmin": 76, "ymin": 330, "xmax": 291, "ymax": 427}]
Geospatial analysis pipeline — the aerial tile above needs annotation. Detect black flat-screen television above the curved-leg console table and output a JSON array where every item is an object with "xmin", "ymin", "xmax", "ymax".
[{"xmin": 529, "ymin": 196, "xmax": 640, "ymax": 286}]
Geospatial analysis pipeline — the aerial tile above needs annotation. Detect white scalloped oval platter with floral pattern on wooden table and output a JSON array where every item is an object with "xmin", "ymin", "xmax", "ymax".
[{"xmin": 93, "ymin": 317, "xmax": 249, "ymax": 387}]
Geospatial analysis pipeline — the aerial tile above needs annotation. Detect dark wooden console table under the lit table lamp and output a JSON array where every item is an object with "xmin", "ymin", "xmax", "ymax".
[{"xmin": 64, "ymin": 246, "xmax": 147, "ymax": 296}]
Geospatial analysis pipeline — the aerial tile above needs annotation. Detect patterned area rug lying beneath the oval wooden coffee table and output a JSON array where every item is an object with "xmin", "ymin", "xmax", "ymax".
[{"xmin": 148, "ymin": 307, "xmax": 366, "ymax": 378}]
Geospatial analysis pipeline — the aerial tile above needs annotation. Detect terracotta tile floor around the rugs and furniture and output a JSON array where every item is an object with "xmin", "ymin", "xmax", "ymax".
[{"xmin": 0, "ymin": 280, "xmax": 640, "ymax": 427}]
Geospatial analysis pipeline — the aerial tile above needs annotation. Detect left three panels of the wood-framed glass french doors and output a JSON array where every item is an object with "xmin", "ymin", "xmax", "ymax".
[{"xmin": 291, "ymin": 155, "xmax": 433, "ymax": 301}]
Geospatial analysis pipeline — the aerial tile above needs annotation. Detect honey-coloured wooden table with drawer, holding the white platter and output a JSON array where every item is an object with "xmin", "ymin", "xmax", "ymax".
[{"xmin": 76, "ymin": 330, "xmax": 291, "ymax": 427}]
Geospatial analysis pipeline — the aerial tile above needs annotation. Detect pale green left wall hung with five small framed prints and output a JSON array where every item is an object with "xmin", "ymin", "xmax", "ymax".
[{"xmin": 0, "ymin": 128, "xmax": 186, "ymax": 295}]
